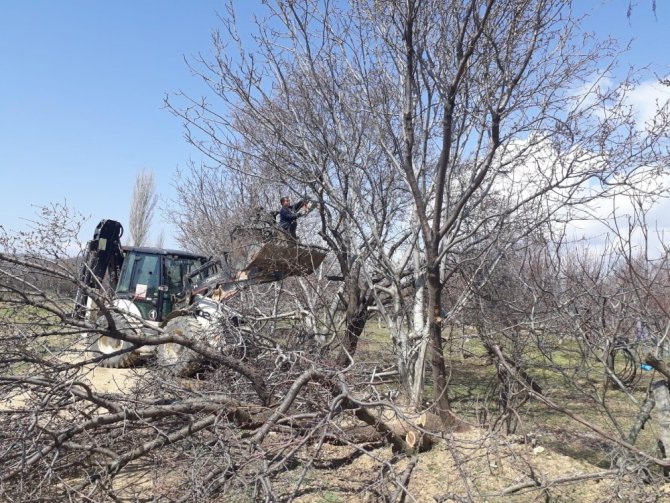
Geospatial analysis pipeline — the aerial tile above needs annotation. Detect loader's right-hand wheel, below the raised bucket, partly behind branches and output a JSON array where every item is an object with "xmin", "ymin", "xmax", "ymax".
[{"xmin": 156, "ymin": 316, "xmax": 203, "ymax": 377}]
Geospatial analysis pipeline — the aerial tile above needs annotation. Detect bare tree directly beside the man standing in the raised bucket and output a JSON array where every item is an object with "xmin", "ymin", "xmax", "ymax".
[{"xmin": 166, "ymin": 6, "xmax": 407, "ymax": 367}]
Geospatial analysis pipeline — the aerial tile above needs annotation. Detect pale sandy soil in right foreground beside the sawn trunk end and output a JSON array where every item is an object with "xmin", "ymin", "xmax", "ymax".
[{"xmin": 276, "ymin": 430, "xmax": 670, "ymax": 503}]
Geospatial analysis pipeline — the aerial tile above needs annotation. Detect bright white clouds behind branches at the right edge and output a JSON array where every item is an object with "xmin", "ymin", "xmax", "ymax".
[{"xmin": 493, "ymin": 120, "xmax": 670, "ymax": 254}]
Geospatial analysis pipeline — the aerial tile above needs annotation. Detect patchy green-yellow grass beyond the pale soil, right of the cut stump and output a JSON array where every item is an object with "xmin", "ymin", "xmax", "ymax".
[{"xmin": 358, "ymin": 323, "xmax": 659, "ymax": 468}]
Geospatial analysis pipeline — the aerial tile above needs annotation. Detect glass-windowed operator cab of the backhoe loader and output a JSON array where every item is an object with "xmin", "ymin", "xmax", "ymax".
[{"xmin": 116, "ymin": 246, "xmax": 207, "ymax": 322}]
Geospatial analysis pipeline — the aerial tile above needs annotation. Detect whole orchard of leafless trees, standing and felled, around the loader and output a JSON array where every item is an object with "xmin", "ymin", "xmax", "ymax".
[{"xmin": 0, "ymin": 0, "xmax": 670, "ymax": 502}]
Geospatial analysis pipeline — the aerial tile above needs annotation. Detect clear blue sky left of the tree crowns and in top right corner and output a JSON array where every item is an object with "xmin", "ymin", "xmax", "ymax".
[{"xmin": 0, "ymin": 0, "xmax": 670, "ymax": 252}]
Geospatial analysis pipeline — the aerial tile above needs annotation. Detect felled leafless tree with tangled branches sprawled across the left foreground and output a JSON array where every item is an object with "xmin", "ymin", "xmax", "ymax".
[{"xmin": 0, "ymin": 207, "xmax": 418, "ymax": 501}]
